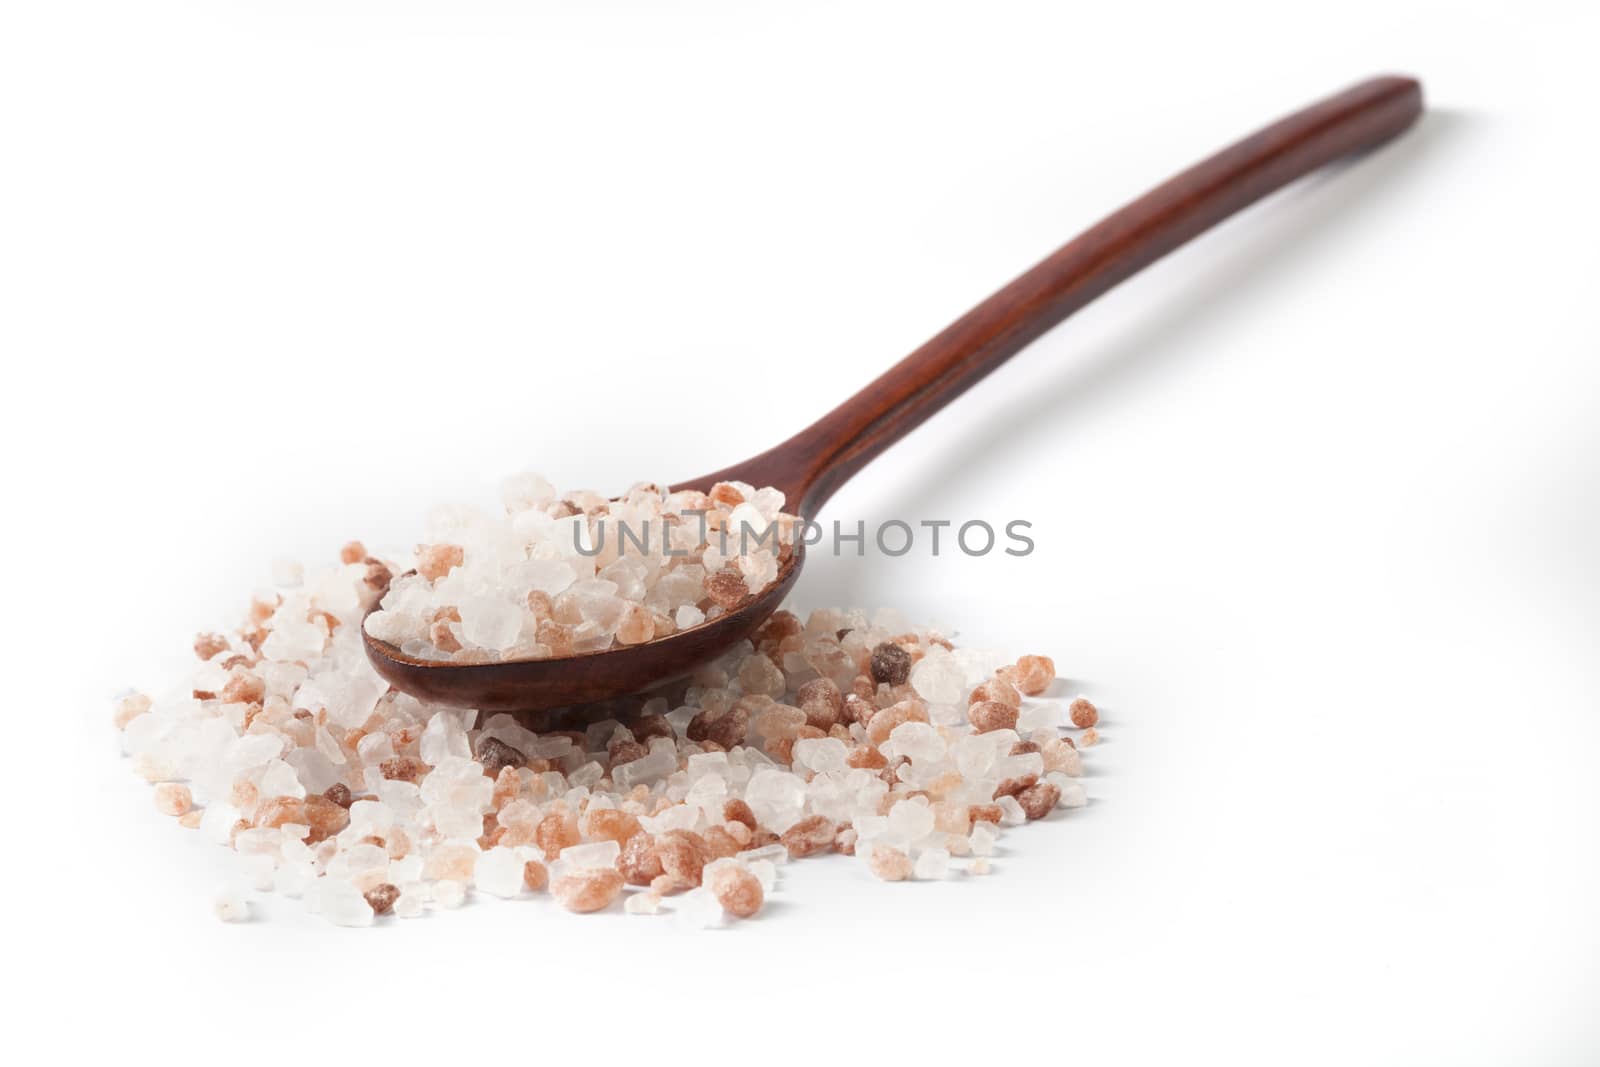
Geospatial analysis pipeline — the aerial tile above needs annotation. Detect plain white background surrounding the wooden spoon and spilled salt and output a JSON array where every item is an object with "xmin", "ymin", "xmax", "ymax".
[{"xmin": 0, "ymin": 0, "xmax": 1600, "ymax": 1065}]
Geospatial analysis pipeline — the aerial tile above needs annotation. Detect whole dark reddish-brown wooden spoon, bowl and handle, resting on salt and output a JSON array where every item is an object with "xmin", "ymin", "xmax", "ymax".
[{"xmin": 363, "ymin": 77, "xmax": 1422, "ymax": 712}]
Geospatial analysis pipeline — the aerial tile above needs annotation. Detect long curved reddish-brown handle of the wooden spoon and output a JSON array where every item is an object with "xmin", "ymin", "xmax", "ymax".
[{"xmin": 685, "ymin": 77, "xmax": 1422, "ymax": 518}]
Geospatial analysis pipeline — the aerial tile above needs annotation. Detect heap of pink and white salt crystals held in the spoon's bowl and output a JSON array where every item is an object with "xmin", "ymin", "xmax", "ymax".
[{"xmin": 366, "ymin": 474, "xmax": 797, "ymax": 662}]
